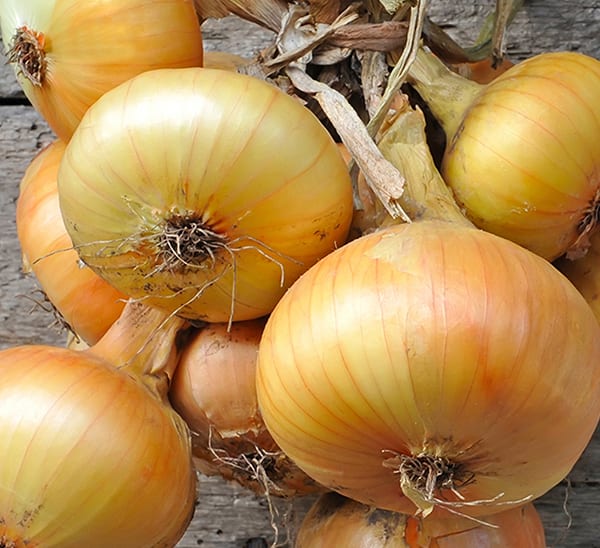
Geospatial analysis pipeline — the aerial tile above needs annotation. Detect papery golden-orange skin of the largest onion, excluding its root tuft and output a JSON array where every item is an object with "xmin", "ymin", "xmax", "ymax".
[{"xmin": 257, "ymin": 221, "xmax": 600, "ymax": 515}]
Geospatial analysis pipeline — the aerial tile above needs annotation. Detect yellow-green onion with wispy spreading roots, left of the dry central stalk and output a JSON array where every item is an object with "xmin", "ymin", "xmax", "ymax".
[{"xmin": 58, "ymin": 68, "xmax": 353, "ymax": 322}]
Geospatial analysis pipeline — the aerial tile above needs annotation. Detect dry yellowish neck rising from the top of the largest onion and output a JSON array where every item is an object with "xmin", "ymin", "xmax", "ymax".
[{"xmin": 378, "ymin": 100, "xmax": 473, "ymax": 226}]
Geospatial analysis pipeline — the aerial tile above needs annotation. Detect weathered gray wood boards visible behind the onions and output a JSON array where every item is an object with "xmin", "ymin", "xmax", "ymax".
[{"xmin": 0, "ymin": 0, "xmax": 600, "ymax": 548}]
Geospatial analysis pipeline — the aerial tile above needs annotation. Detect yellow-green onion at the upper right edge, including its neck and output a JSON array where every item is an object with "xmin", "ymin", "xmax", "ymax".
[{"xmin": 411, "ymin": 47, "xmax": 600, "ymax": 260}]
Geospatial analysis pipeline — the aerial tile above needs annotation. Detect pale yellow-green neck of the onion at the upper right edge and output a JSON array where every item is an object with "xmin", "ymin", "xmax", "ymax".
[{"xmin": 408, "ymin": 48, "xmax": 485, "ymax": 140}]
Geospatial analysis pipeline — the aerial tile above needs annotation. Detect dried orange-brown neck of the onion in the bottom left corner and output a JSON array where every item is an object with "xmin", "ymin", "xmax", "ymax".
[{"xmin": 86, "ymin": 301, "xmax": 188, "ymax": 399}]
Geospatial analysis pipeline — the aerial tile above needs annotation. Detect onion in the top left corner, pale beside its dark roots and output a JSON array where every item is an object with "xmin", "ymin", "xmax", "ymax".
[{"xmin": 0, "ymin": 0, "xmax": 203, "ymax": 140}]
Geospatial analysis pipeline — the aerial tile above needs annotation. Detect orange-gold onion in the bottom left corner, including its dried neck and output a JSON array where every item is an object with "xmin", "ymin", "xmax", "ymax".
[{"xmin": 0, "ymin": 304, "xmax": 196, "ymax": 548}]
